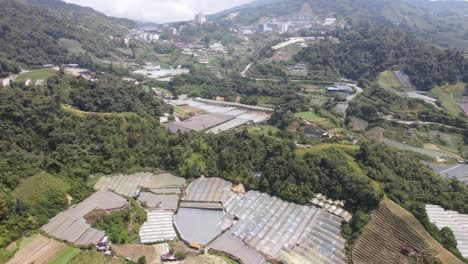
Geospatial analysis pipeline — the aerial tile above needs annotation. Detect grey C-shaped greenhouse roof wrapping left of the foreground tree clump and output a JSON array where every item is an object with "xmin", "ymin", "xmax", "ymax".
[{"xmin": 41, "ymin": 190, "xmax": 127, "ymax": 245}]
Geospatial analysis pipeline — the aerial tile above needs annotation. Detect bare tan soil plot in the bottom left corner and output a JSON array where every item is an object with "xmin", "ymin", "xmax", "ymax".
[{"xmin": 7, "ymin": 235, "xmax": 68, "ymax": 264}]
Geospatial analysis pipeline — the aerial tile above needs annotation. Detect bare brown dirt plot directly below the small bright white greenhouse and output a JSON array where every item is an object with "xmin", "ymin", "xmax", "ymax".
[{"xmin": 112, "ymin": 243, "xmax": 170, "ymax": 264}]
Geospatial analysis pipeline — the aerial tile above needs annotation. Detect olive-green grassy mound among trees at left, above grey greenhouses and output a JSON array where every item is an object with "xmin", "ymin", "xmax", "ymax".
[{"xmin": 13, "ymin": 173, "xmax": 70, "ymax": 204}]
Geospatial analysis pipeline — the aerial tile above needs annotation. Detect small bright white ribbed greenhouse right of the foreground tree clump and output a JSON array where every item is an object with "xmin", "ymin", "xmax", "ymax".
[{"xmin": 139, "ymin": 210, "xmax": 177, "ymax": 243}]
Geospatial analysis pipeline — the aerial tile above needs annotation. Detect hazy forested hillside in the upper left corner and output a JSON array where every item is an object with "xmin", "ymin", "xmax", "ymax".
[{"xmin": 0, "ymin": 0, "xmax": 132, "ymax": 65}]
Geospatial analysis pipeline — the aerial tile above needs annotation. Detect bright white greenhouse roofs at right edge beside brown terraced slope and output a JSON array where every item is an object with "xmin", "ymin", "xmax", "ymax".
[{"xmin": 426, "ymin": 204, "xmax": 468, "ymax": 258}]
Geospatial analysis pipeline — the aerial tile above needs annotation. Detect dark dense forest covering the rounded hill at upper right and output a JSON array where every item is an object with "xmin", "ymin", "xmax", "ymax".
[{"xmin": 295, "ymin": 21, "xmax": 468, "ymax": 91}]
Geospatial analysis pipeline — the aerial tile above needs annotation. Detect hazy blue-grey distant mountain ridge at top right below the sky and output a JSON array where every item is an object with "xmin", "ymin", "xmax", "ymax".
[{"xmin": 213, "ymin": 0, "xmax": 468, "ymax": 50}]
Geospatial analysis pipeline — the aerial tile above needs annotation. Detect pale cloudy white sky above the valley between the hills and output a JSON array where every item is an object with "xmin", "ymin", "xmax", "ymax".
[{"xmin": 65, "ymin": 0, "xmax": 252, "ymax": 23}]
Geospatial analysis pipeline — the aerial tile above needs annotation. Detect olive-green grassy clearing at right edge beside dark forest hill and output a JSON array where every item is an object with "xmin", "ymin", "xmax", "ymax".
[{"xmin": 431, "ymin": 83, "xmax": 465, "ymax": 115}]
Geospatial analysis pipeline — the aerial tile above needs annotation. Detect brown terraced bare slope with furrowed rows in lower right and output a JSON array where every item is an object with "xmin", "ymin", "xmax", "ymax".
[{"xmin": 352, "ymin": 199, "xmax": 463, "ymax": 264}]
